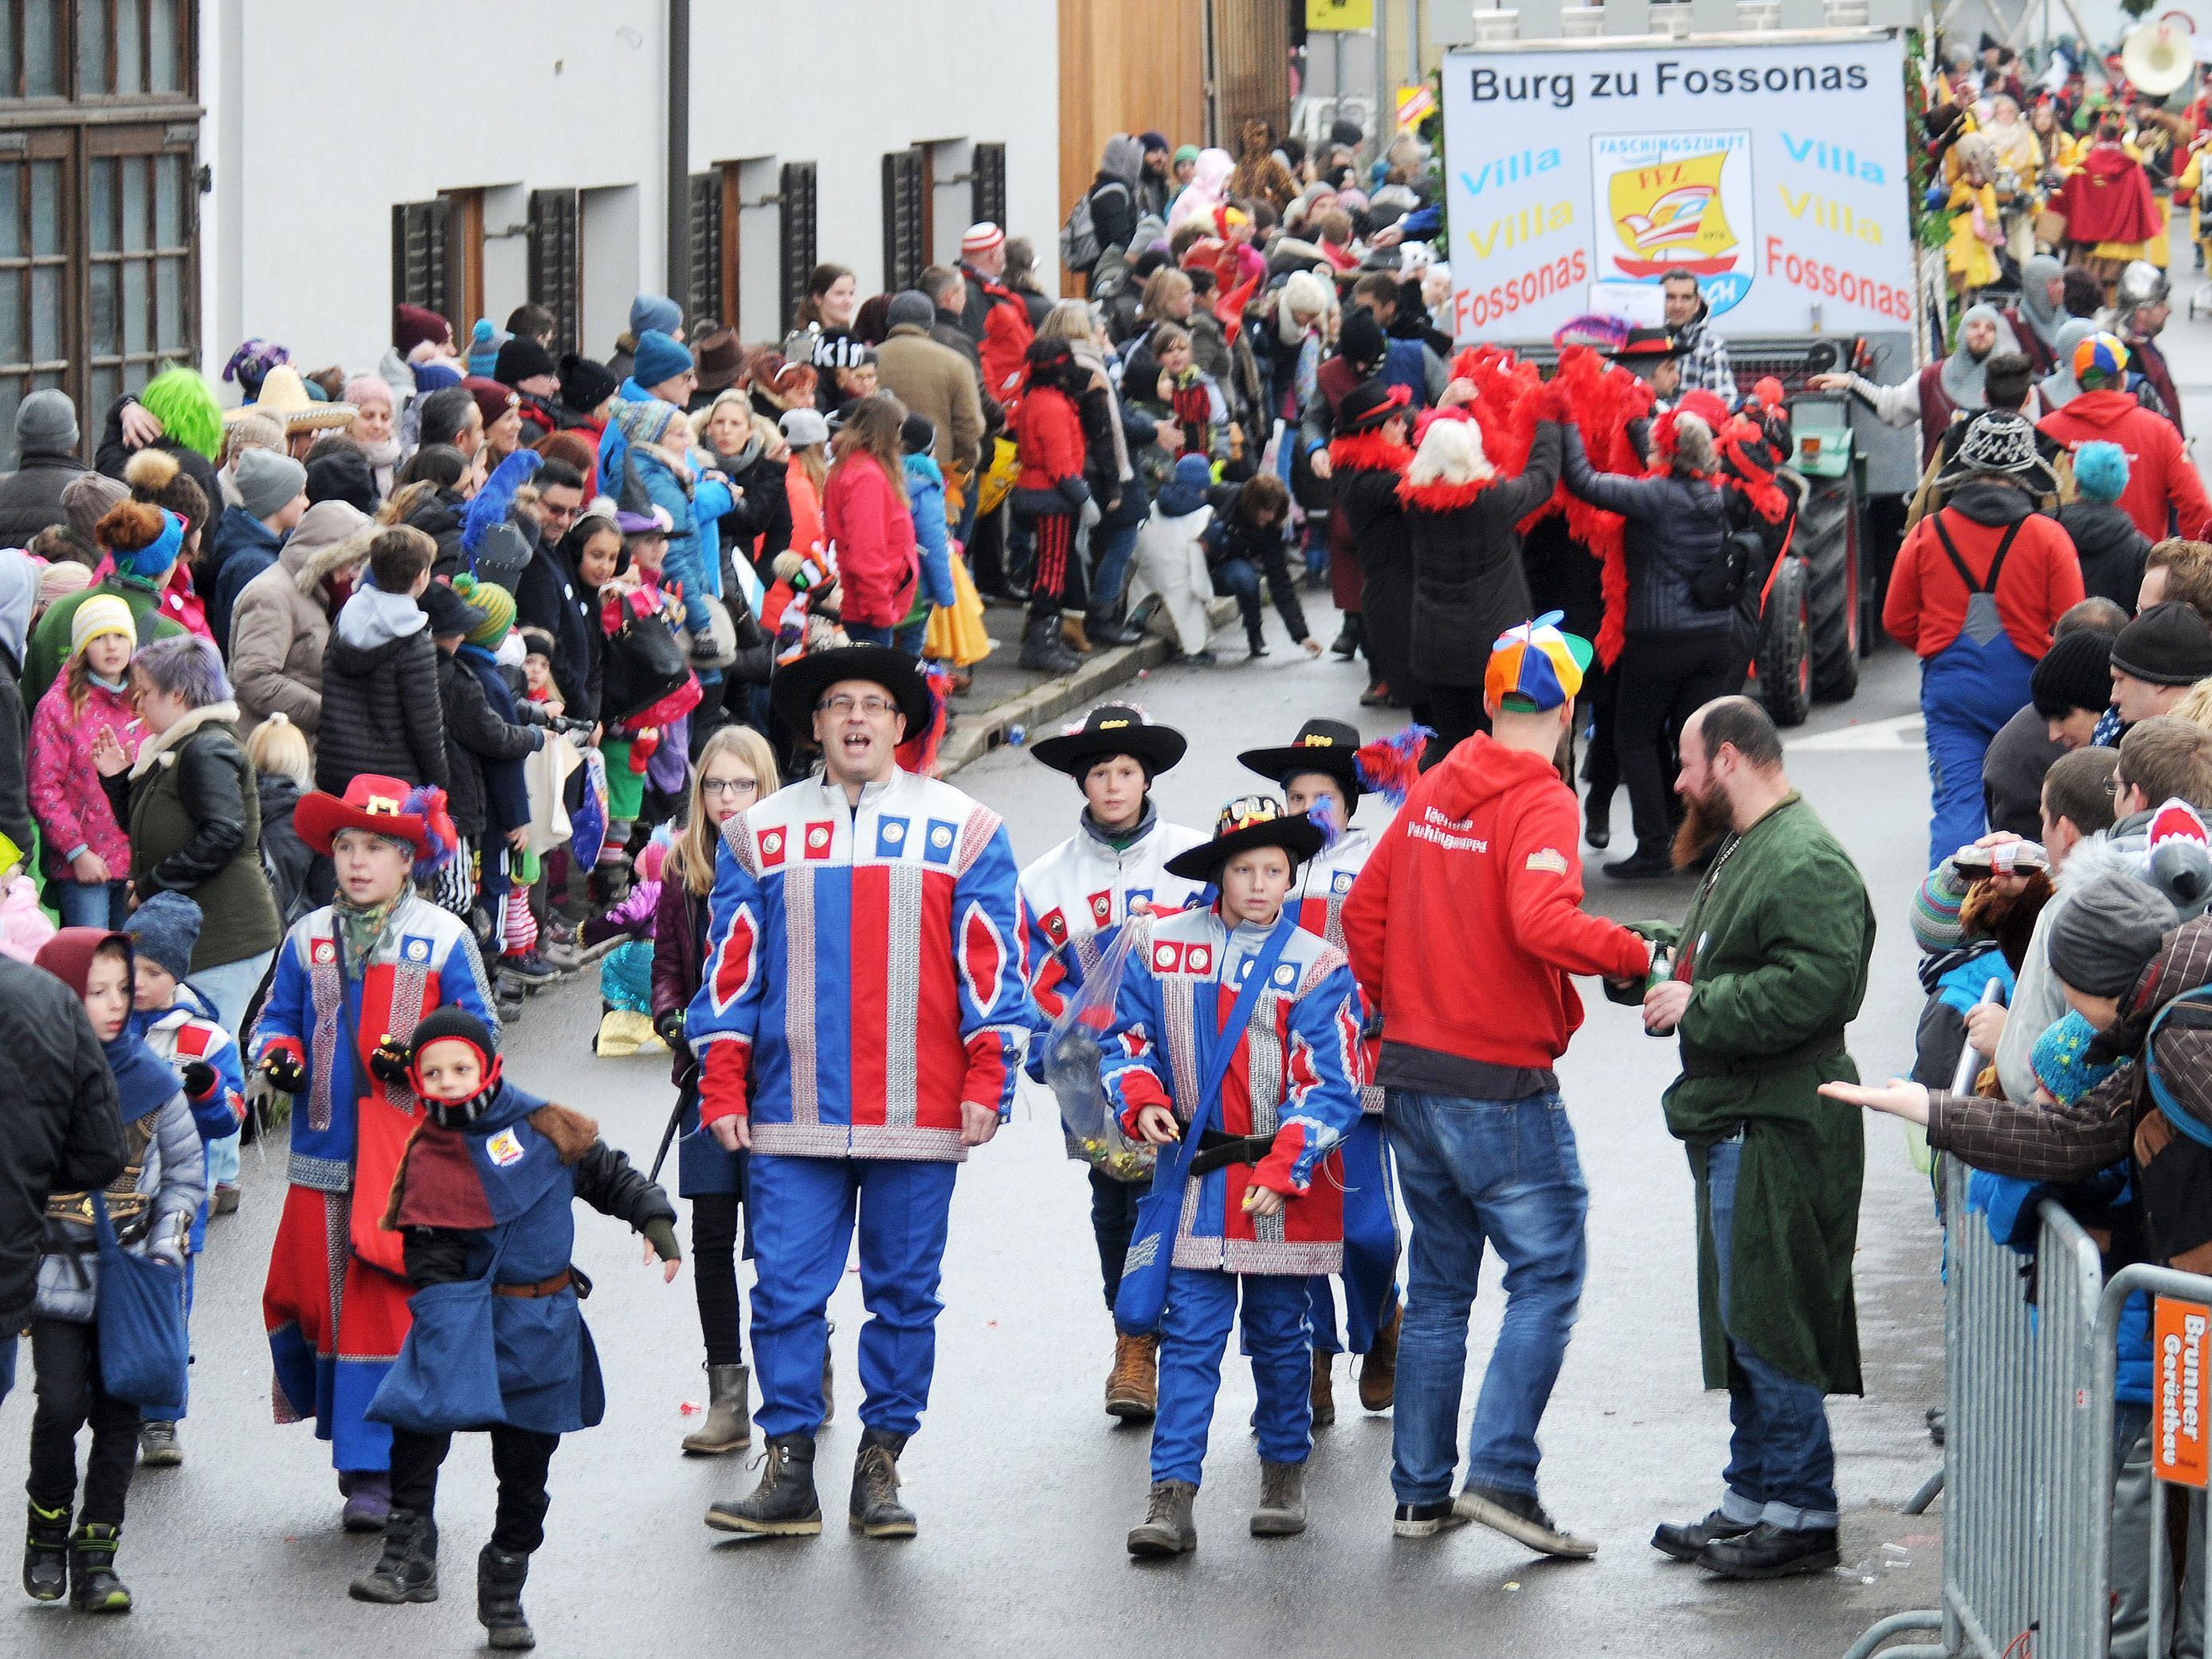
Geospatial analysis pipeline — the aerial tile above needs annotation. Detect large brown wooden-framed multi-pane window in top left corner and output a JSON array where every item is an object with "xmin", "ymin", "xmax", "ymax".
[{"xmin": 0, "ymin": 0, "xmax": 202, "ymax": 465}]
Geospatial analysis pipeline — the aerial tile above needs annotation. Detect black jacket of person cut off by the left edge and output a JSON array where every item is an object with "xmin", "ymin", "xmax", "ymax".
[{"xmin": 0, "ymin": 955, "xmax": 124, "ymax": 1338}]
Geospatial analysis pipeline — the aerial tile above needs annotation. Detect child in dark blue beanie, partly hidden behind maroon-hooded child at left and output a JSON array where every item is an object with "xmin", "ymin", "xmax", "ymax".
[{"xmin": 124, "ymin": 892, "xmax": 245, "ymax": 1469}]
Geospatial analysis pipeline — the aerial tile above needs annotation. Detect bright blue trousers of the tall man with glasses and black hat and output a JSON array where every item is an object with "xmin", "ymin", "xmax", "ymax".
[{"xmin": 746, "ymin": 1152, "xmax": 960, "ymax": 1436}]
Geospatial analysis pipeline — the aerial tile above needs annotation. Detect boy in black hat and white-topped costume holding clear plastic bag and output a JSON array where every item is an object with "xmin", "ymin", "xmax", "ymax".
[{"xmin": 1022, "ymin": 704, "xmax": 1206, "ymax": 1422}]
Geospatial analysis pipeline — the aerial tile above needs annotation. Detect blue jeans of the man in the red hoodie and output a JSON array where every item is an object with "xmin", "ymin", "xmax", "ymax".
[{"xmin": 1382, "ymin": 1088, "xmax": 1590, "ymax": 1504}]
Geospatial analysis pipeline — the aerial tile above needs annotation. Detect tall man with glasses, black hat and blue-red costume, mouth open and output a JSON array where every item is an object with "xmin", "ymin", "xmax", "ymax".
[{"xmin": 684, "ymin": 646, "xmax": 1035, "ymax": 1537}]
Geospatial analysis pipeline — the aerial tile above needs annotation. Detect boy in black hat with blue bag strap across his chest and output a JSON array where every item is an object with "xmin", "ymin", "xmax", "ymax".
[{"xmin": 1101, "ymin": 796, "xmax": 1365, "ymax": 1555}]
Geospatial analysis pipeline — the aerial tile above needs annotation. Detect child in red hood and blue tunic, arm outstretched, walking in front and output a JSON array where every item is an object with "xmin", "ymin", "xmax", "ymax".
[{"xmin": 351, "ymin": 1006, "xmax": 679, "ymax": 1648}]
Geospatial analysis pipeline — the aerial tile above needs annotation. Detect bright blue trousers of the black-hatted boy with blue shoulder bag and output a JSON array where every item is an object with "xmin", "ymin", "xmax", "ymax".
[{"xmin": 1159, "ymin": 1268, "xmax": 1314, "ymax": 1486}]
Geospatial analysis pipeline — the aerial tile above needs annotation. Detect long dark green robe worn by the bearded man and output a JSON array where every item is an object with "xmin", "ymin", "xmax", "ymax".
[{"xmin": 1644, "ymin": 792, "xmax": 1873, "ymax": 1394}]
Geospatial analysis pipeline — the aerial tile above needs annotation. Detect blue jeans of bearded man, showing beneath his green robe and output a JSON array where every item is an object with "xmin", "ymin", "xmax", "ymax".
[{"xmin": 1705, "ymin": 1141, "xmax": 1836, "ymax": 1533}]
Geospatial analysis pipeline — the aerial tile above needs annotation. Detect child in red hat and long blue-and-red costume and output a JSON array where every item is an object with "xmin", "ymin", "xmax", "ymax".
[{"xmin": 252, "ymin": 772, "xmax": 491, "ymax": 1533}]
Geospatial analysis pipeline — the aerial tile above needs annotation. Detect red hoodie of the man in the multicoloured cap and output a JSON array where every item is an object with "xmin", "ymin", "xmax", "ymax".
[{"xmin": 1343, "ymin": 732, "xmax": 1650, "ymax": 1071}]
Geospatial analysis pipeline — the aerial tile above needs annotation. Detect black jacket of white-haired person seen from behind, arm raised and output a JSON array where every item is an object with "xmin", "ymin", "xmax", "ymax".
[{"xmin": 1402, "ymin": 420, "xmax": 1559, "ymax": 686}]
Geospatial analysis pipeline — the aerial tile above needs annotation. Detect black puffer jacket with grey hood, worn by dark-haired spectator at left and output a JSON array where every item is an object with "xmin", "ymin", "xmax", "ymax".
[{"xmin": 314, "ymin": 588, "xmax": 451, "ymax": 794}]
